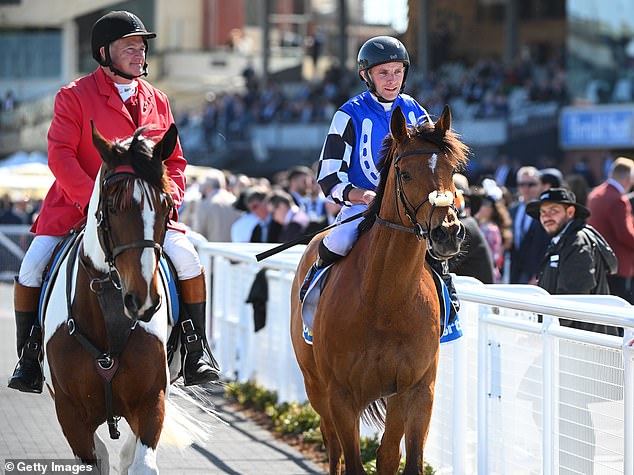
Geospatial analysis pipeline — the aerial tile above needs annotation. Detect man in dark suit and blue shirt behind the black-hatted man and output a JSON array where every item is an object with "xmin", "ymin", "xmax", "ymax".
[{"xmin": 510, "ymin": 166, "xmax": 549, "ymax": 284}]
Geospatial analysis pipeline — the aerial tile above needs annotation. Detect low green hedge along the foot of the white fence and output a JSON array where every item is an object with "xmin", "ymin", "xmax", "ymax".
[{"xmin": 225, "ymin": 381, "xmax": 436, "ymax": 475}]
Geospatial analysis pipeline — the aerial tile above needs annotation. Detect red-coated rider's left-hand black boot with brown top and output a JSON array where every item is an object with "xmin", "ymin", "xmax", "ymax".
[{"xmin": 9, "ymin": 279, "xmax": 44, "ymax": 393}]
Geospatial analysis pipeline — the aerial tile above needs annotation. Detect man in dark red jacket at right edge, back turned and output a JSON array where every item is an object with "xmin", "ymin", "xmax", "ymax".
[{"xmin": 587, "ymin": 157, "xmax": 634, "ymax": 303}]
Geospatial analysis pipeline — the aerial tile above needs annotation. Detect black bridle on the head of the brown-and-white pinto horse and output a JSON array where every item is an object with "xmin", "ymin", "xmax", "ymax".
[{"xmin": 97, "ymin": 165, "xmax": 173, "ymax": 282}]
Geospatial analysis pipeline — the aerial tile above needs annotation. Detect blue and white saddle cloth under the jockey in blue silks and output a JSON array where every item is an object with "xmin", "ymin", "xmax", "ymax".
[{"xmin": 302, "ymin": 264, "xmax": 462, "ymax": 345}]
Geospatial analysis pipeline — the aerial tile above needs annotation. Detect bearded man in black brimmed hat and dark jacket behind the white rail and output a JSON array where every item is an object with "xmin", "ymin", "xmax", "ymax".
[{"xmin": 526, "ymin": 188, "xmax": 617, "ymax": 324}]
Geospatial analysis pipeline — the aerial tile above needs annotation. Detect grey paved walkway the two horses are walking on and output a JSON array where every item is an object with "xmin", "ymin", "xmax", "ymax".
[{"xmin": 0, "ymin": 283, "xmax": 322, "ymax": 475}]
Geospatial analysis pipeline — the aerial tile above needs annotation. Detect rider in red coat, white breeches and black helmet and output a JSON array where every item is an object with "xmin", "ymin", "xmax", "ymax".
[{"xmin": 9, "ymin": 11, "xmax": 219, "ymax": 393}]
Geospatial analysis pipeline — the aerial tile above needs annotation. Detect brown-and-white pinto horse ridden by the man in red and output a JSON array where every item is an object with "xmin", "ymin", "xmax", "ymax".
[{"xmin": 43, "ymin": 124, "xmax": 178, "ymax": 474}]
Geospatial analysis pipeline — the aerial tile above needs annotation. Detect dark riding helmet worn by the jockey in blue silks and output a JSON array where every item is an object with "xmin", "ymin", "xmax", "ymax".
[{"xmin": 357, "ymin": 36, "xmax": 409, "ymax": 99}]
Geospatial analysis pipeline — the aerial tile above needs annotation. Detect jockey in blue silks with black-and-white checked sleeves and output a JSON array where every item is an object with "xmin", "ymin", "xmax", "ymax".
[{"xmin": 300, "ymin": 36, "xmax": 459, "ymax": 330}]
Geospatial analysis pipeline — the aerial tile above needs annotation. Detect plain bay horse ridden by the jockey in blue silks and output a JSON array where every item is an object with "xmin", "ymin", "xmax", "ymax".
[{"xmin": 291, "ymin": 106, "xmax": 468, "ymax": 475}]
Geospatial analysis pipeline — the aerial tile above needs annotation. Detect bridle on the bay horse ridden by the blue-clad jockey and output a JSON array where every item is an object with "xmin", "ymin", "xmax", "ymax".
[{"xmin": 376, "ymin": 148, "xmax": 458, "ymax": 247}]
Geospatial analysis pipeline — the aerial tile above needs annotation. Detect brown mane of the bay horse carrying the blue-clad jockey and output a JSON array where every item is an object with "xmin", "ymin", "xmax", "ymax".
[{"xmin": 359, "ymin": 120, "xmax": 469, "ymax": 232}]
